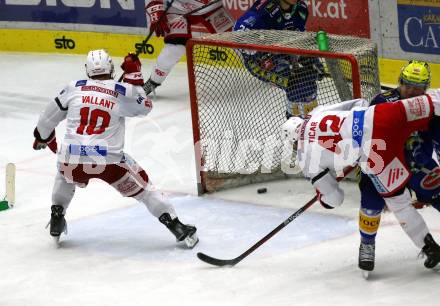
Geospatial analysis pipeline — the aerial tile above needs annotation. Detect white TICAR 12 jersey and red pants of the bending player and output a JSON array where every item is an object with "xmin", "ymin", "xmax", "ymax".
[{"xmin": 297, "ymin": 94, "xmax": 438, "ymax": 196}]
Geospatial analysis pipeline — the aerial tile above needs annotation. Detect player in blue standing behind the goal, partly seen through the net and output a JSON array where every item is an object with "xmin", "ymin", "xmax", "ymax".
[{"xmin": 234, "ymin": 0, "xmax": 324, "ymax": 118}]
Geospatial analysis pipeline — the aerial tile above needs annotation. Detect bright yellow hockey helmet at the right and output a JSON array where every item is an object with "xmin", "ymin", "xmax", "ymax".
[{"xmin": 399, "ymin": 60, "xmax": 431, "ymax": 90}]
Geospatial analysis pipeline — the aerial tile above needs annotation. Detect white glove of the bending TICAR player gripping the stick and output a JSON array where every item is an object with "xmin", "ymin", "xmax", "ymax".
[{"xmin": 311, "ymin": 169, "xmax": 344, "ymax": 209}]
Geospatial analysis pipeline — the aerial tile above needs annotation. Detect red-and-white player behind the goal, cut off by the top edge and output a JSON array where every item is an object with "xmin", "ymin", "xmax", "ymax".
[{"xmin": 144, "ymin": 0, "xmax": 234, "ymax": 95}]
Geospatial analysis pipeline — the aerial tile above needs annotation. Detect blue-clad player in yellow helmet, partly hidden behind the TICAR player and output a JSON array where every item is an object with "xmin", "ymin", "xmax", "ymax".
[{"xmin": 359, "ymin": 61, "xmax": 440, "ymax": 271}]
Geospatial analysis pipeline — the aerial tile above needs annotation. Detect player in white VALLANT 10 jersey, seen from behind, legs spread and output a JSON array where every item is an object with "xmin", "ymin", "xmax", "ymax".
[{"xmin": 33, "ymin": 50, "xmax": 198, "ymax": 248}]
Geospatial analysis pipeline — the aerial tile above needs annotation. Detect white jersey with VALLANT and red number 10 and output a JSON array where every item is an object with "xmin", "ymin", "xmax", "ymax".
[{"xmin": 37, "ymin": 79, "xmax": 153, "ymax": 164}]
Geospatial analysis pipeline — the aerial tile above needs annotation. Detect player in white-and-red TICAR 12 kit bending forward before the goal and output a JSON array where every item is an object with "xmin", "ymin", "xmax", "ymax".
[{"xmin": 283, "ymin": 89, "xmax": 440, "ymax": 268}]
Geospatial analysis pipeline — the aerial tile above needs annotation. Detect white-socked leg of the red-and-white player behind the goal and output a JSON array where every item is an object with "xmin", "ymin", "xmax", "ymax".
[{"xmin": 144, "ymin": 14, "xmax": 191, "ymax": 94}]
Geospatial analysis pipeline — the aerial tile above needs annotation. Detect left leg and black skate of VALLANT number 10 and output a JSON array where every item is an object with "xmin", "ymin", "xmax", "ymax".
[{"xmin": 49, "ymin": 172, "xmax": 75, "ymax": 237}]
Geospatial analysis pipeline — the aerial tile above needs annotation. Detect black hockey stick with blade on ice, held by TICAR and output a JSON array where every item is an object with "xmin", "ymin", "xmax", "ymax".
[{"xmin": 197, "ymin": 167, "xmax": 354, "ymax": 267}]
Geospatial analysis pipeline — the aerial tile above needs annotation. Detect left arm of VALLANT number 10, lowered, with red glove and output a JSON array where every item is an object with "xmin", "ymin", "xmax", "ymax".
[{"xmin": 33, "ymin": 86, "xmax": 70, "ymax": 153}]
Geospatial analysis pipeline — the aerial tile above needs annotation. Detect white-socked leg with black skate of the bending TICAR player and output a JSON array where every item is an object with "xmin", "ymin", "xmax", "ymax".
[{"xmin": 385, "ymin": 188, "xmax": 440, "ymax": 268}]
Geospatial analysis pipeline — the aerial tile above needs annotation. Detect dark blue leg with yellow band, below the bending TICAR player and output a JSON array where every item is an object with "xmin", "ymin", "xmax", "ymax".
[{"xmin": 358, "ymin": 173, "xmax": 385, "ymax": 271}]
